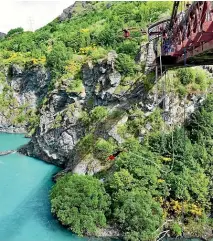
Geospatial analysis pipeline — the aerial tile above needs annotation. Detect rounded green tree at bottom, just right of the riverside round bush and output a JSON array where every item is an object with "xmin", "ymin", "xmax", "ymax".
[{"xmin": 113, "ymin": 189, "xmax": 163, "ymax": 241}]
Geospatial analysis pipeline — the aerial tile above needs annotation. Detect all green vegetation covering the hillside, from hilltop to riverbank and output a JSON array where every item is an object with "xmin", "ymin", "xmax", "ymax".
[{"xmin": 0, "ymin": 1, "xmax": 213, "ymax": 241}]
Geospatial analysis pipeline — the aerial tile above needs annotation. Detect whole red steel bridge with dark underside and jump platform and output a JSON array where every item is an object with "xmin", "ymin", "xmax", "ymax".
[{"xmin": 148, "ymin": 1, "xmax": 213, "ymax": 68}]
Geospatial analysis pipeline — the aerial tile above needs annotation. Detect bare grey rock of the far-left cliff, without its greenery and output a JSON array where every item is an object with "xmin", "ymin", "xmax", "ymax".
[{"xmin": 0, "ymin": 65, "xmax": 50, "ymax": 133}]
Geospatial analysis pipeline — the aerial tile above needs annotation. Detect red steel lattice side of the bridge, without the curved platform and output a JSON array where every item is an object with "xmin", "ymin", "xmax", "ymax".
[{"xmin": 162, "ymin": 1, "xmax": 213, "ymax": 56}]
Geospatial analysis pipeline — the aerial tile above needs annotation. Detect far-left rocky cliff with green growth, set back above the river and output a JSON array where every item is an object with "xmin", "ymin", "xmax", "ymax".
[{"xmin": 0, "ymin": 64, "xmax": 50, "ymax": 133}]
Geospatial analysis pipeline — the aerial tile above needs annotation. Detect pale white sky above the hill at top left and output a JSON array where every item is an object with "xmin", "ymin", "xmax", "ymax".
[{"xmin": 0, "ymin": 0, "xmax": 74, "ymax": 33}]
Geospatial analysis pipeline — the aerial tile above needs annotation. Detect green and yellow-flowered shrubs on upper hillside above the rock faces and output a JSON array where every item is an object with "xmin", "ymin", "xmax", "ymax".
[{"xmin": 0, "ymin": 2, "xmax": 172, "ymax": 133}]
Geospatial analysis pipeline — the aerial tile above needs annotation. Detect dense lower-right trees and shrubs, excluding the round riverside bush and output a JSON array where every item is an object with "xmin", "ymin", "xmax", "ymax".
[{"xmin": 51, "ymin": 95, "xmax": 213, "ymax": 241}]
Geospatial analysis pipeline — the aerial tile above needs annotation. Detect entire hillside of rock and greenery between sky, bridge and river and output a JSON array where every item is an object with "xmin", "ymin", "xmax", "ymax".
[{"xmin": 0, "ymin": 2, "xmax": 213, "ymax": 241}]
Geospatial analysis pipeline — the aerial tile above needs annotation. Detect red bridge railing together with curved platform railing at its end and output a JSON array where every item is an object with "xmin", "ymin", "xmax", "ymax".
[{"xmin": 148, "ymin": 1, "xmax": 213, "ymax": 63}]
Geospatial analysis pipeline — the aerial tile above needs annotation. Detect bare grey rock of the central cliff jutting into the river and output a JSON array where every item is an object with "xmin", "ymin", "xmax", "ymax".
[{"xmin": 19, "ymin": 51, "xmax": 209, "ymax": 175}]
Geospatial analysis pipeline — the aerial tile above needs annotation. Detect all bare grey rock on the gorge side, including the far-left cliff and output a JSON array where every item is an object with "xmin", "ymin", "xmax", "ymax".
[{"xmin": 0, "ymin": 46, "xmax": 209, "ymax": 175}]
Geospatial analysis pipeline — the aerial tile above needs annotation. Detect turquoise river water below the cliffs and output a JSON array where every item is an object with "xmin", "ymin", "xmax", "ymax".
[{"xmin": 0, "ymin": 133, "xmax": 206, "ymax": 241}]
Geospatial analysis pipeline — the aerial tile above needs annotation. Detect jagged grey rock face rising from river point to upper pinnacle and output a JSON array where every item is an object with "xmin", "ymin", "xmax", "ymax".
[{"xmin": 21, "ymin": 52, "xmax": 121, "ymax": 168}]
